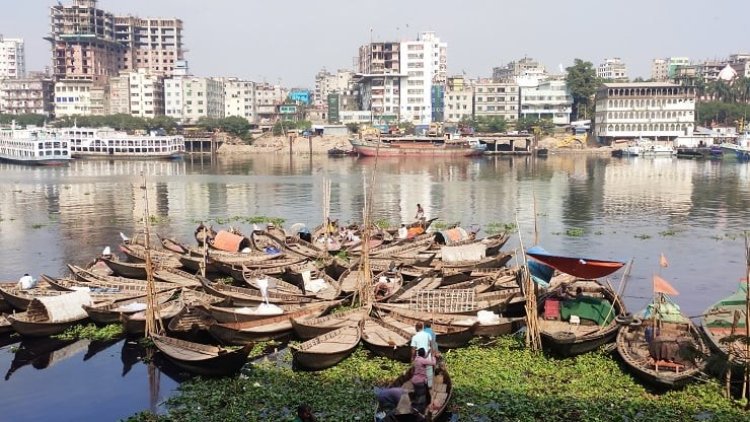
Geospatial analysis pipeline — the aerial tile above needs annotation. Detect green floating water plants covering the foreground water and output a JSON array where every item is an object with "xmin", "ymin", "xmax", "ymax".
[{"xmin": 130, "ymin": 337, "xmax": 750, "ymax": 422}]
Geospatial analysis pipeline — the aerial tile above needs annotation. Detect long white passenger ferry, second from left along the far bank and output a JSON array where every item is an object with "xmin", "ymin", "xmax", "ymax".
[{"xmin": 61, "ymin": 127, "xmax": 185, "ymax": 159}]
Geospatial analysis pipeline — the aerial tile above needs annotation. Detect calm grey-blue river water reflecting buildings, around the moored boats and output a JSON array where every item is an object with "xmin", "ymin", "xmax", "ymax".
[{"xmin": 0, "ymin": 155, "xmax": 750, "ymax": 420}]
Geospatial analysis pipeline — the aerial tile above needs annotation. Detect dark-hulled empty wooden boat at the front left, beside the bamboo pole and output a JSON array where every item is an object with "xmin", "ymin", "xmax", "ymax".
[{"xmin": 151, "ymin": 335, "xmax": 252, "ymax": 376}]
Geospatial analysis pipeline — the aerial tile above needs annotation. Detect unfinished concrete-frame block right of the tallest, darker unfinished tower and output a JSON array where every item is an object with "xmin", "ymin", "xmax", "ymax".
[{"xmin": 115, "ymin": 16, "xmax": 184, "ymax": 76}]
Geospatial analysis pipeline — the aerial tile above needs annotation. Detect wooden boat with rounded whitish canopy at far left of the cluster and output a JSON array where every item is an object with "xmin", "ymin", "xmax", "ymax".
[{"xmin": 7, "ymin": 292, "xmax": 92, "ymax": 337}]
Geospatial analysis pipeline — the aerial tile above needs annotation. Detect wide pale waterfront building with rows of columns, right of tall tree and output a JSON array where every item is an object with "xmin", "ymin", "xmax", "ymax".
[{"xmin": 594, "ymin": 82, "xmax": 695, "ymax": 143}]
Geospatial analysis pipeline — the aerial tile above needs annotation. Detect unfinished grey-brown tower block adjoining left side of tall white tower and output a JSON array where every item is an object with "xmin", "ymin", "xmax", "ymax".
[{"xmin": 355, "ymin": 42, "xmax": 407, "ymax": 123}]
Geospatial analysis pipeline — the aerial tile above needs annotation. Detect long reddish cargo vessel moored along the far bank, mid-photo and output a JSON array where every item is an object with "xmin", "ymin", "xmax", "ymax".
[{"xmin": 349, "ymin": 136, "xmax": 487, "ymax": 157}]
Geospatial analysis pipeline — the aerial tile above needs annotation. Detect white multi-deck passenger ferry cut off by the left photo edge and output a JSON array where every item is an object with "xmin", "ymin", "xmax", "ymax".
[{"xmin": 0, "ymin": 124, "xmax": 72, "ymax": 166}]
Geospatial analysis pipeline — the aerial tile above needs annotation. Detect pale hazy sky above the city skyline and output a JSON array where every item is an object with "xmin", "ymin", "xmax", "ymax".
[{"xmin": 0, "ymin": 0, "xmax": 750, "ymax": 87}]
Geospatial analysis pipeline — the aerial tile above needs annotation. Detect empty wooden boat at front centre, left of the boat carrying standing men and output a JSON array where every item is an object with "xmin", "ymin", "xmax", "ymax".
[{"xmin": 291, "ymin": 324, "xmax": 362, "ymax": 371}]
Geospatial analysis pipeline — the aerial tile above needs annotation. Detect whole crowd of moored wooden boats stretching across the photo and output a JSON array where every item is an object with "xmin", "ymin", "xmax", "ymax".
[{"xmin": 0, "ymin": 221, "xmax": 747, "ymax": 396}]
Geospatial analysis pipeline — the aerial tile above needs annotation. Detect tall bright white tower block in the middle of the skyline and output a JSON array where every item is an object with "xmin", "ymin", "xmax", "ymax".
[{"xmin": 399, "ymin": 32, "xmax": 448, "ymax": 125}]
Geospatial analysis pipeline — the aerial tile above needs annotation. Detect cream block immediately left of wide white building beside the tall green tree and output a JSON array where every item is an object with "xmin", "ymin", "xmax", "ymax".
[{"xmin": 474, "ymin": 79, "xmax": 520, "ymax": 123}]
